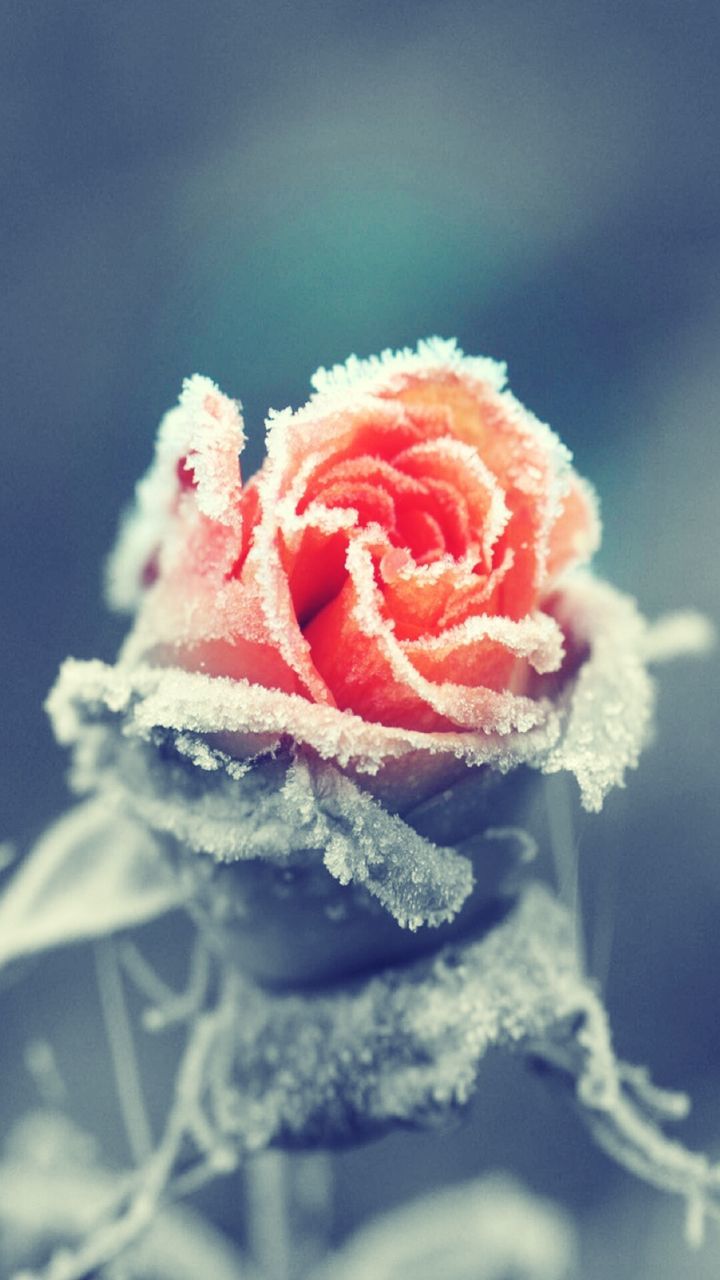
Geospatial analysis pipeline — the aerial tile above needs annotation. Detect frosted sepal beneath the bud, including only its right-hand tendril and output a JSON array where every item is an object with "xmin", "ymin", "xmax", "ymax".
[{"xmin": 176, "ymin": 886, "xmax": 720, "ymax": 1249}]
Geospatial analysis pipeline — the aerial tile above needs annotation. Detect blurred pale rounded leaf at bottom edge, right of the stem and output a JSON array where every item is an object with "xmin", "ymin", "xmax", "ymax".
[{"xmin": 314, "ymin": 1176, "xmax": 577, "ymax": 1280}]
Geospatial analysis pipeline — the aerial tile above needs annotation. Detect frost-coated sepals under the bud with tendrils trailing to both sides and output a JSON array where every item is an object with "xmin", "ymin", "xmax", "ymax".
[{"xmin": 12, "ymin": 886, "xmax": 720, "ymax": 1280}]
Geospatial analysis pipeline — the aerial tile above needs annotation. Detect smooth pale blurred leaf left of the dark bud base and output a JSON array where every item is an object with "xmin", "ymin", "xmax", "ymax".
[{"xmin": 0, "ymin": 797, "xmax": 183, "ymax": 965}]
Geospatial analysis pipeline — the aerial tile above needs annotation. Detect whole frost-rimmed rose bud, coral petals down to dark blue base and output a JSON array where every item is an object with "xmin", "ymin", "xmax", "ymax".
[{"xmin": 50, "ymin": 339, "xmax": 666, "ymax": 986}]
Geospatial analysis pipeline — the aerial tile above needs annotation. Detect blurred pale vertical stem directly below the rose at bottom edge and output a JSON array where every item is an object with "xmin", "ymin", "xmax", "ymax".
[{"xmin": 246, "ymin": 1151, "xmax": 332, "ymax": 1280}]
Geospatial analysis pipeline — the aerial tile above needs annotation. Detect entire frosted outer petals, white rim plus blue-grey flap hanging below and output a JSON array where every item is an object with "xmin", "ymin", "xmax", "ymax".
[{"xmin": 37, "ymin": 573, "xmax": 676, "ymax": 928}]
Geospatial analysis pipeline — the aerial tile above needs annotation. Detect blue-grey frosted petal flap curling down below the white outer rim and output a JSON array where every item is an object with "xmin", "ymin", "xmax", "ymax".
[{"xmin": 44, "ymin": 673, "xmax": 473, "ymax": 928}]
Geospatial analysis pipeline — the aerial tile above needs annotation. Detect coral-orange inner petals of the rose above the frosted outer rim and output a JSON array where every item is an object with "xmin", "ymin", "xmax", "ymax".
[{"xmin": 112, "ymin": 340, "xmax": 598, "ymax": 762}]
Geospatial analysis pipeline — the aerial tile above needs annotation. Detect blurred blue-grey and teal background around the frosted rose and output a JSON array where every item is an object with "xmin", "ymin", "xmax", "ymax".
[{"xmin": 0, "ymin": 0, "xmax": 720, "ymax": 1280}]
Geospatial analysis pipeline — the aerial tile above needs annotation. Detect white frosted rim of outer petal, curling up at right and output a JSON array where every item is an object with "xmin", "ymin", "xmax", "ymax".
[{"xmin": 47, "ymin": 563, "xmax": 661, "ymax": 829}]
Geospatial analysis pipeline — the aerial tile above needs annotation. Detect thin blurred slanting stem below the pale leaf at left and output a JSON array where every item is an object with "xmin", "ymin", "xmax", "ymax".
[{"xmin": 95, "ymin": 938, "xmax": 152, "ymax": 1166}]
